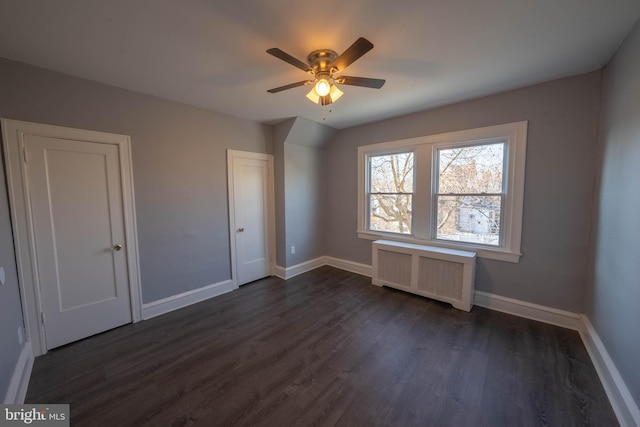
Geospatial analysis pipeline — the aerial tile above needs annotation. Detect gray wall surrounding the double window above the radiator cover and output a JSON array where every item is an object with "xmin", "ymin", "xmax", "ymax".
[{"xmin": 326, "ymin": 72, "xmax": 601, "ymax": 312}]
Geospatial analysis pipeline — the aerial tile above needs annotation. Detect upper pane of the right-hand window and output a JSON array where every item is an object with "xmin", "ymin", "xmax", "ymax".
[{"xmin": 437, "ymin": 142, "xmax": 505, "ymax": 194}]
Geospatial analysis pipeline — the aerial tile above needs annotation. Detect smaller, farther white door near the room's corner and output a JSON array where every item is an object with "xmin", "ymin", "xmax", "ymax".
[{"xmin": 230, "ymin": 152, "xmax": 271, "ymax": 285}]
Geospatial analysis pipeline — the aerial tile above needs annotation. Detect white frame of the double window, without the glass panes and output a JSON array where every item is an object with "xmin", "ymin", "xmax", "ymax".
[{"xmin": 357, "ymin": 121, "xmax": 528, "ymax": 263}]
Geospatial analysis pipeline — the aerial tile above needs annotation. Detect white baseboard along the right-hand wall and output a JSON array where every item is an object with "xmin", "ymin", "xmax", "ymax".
[{"xmin": 578, "ymin": 315, "xmax": 640, "ymax": 427}]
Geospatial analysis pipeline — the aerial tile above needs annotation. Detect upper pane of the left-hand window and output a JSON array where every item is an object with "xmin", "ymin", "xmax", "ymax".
[{"xmin": 369, "ymin": 153, "xmax": 413, "ymax": 193}]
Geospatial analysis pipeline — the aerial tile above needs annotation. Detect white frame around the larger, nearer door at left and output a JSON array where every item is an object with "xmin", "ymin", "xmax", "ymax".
[{"xmin": 0, "ymin": 119, "xmax": 142, "ymax": 357}]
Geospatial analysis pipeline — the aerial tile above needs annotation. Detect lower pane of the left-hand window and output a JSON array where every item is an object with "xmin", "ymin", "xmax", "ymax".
[{"xmin": 369, "ymin": 194, "xmax": 412, "ymax": 234}]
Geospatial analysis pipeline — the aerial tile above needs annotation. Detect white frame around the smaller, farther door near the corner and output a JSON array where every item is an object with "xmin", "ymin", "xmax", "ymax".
[{"xmin": 227, "ymin": 149, "xmax": 276, "ymax": 289}]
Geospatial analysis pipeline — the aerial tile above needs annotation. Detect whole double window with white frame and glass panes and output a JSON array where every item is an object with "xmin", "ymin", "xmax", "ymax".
[{"xmin": 358, "ymin": 122, "xmax": 527, "ymax": 262}]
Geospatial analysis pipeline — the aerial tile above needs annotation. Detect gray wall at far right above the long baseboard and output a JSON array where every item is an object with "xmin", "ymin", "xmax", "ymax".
[{"xmin": 585, "ymin": 20, "xmax": 640, "ymax": 405}]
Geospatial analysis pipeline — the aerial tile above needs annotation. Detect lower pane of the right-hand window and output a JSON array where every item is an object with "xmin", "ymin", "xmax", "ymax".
[{"xmin": 437, "ymin": 196, "xmax": 502, "ymax": 246}]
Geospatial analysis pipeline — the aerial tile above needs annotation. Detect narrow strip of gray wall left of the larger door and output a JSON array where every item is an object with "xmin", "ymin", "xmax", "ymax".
[{"xmin": 0, "ymin": 161, "xmax": 24, "ymax": 400}]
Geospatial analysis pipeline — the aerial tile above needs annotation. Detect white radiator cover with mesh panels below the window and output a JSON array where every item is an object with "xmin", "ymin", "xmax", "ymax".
[{"xmin": 372, "ymin": 240, "xmax": 476, "ymax": 311}]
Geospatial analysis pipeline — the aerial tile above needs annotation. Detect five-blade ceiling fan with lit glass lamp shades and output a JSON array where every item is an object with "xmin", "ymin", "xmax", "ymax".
[{"xmin": 267, "ymin": 37, "xmax": 385, "ymax": 105}]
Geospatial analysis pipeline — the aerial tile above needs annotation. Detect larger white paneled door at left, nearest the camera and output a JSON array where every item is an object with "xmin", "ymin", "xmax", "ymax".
[{"xmin": 24, "ymin": 135, "xmax": 132, "ymax": 349}]
